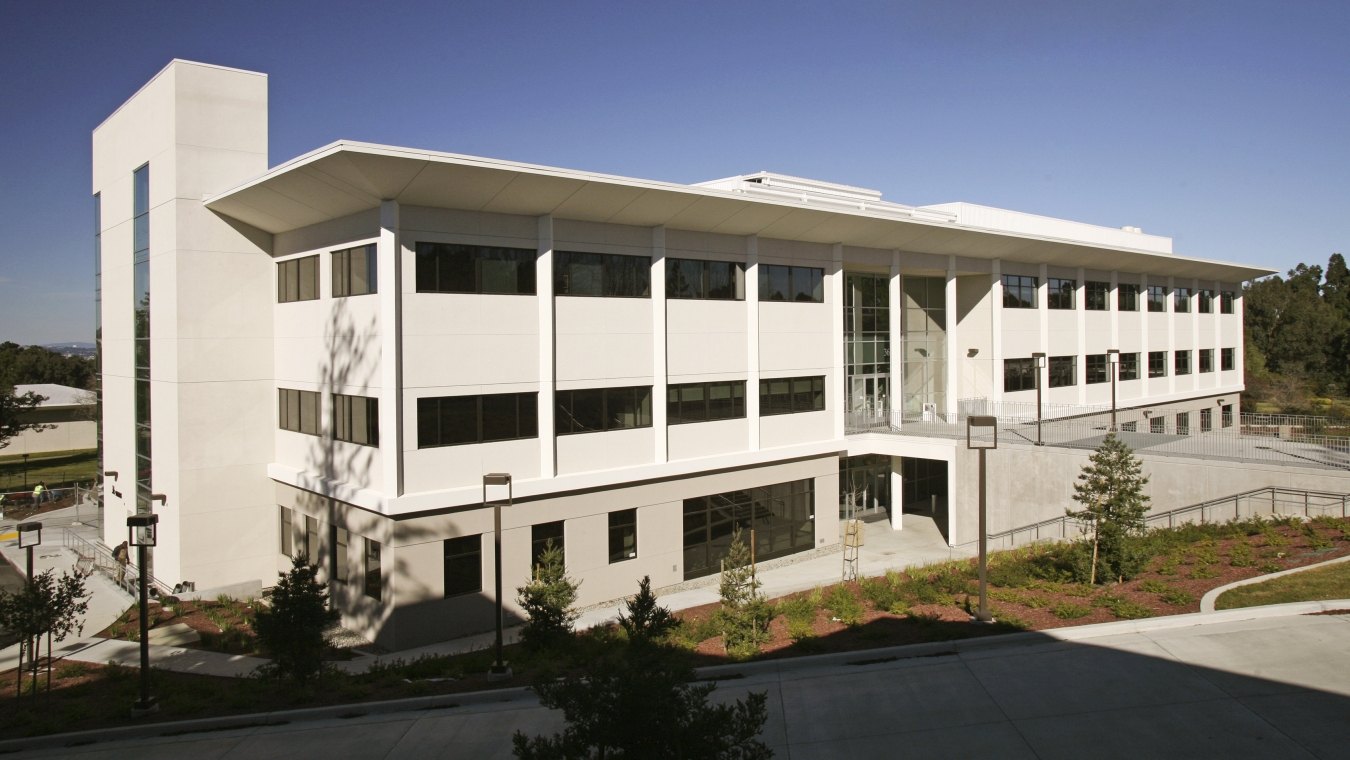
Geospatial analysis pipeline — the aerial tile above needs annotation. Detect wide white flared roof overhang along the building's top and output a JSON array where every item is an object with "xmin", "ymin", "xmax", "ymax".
[{"xmin": 204, "ymin": 142, "xmax": 1273, "ymax": 282}]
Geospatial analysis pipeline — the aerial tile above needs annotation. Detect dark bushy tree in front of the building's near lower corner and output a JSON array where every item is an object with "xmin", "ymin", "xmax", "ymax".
[{"xmin": 254, "ymin": 555, "xmax": 338, "ymax": 683}]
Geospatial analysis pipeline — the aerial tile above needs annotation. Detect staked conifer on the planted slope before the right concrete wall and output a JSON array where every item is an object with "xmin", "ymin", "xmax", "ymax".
[{"xmin": 1067, "ymin": 433, "xmax": 1149, "ymax": 583}]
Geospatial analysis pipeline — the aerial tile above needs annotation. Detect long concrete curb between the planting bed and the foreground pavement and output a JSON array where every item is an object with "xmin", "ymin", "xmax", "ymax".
[{"xmin": 0, "ymin": 602, "xmax": 1350, "ymax": 753}]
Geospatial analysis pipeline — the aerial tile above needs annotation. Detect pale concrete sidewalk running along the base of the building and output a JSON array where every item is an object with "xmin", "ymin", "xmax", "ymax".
[{"xmin": 0, "ymin": 508, "xmax": 972, "ymax": 676}]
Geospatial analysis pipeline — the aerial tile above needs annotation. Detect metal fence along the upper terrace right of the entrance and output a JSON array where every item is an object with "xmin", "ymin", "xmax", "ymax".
[{"xmin": 844, "ymin": 398, "xmax": 1350, "ymax": 470}]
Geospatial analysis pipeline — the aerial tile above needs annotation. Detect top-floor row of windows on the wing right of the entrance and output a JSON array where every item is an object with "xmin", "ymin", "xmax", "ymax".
[{"xmin": 1003, "ymin": 274, "xmax": 1237, "ymax": 315}]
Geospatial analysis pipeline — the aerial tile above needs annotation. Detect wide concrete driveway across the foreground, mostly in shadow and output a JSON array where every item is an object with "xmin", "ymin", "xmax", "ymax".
[{"xmin": 10, "ymin": 602, "xmax": 1350, "ymax": 760}]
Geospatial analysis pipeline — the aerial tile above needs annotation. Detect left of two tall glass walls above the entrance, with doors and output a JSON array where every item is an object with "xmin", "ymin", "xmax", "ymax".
[{"xmin": 844, "ymin": 271, "xmax": 891, "ymax": 414}]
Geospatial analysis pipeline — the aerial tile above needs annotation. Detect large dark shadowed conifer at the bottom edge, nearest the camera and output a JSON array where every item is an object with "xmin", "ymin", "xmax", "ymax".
[{"xmin": 513, "ymin": 578, "xmax": 772, "ymax": 760}]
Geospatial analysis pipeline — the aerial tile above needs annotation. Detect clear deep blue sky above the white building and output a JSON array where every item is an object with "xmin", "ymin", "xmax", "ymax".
[{"xmin": 0, "ymin": 0, "xmax": 1350, "ymax": 343}]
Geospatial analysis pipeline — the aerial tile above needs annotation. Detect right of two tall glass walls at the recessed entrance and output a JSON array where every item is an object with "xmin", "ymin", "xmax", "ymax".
[{"xmin": 900, "ymin": 275, "xmax": 946, "ymax": 420}]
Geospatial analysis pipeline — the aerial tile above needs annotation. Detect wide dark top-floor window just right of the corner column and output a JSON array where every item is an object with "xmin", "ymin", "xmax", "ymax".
[{"xmin": 416, "ymin": 243, "xmax": 539, "ymax": 296}]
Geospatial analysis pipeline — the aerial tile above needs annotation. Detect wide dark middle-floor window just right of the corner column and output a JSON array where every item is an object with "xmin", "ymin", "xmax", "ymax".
[{"xmin": 417, "ymin": 393, "xmax": 539, "ymax": 448}]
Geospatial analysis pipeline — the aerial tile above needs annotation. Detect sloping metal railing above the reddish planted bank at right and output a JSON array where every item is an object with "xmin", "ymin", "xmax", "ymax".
[{"xmin": 957, "ymin": 486, "xmax": 1350, "ymax": 549}]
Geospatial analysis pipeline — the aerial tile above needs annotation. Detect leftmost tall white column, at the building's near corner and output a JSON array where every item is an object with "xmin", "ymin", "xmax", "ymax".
[{"xmin": 378, "ymin": 201, "xmax": 404, "ymax": 497}]
